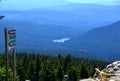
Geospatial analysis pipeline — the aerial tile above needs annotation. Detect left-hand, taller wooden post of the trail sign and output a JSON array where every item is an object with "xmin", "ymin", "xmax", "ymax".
[{"xmin": 4, "ymin": 28, "xmax": 8, "ymax": 81}]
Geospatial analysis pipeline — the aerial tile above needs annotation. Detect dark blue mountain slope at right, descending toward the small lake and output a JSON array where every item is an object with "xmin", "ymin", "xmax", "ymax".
[{"xmin": 64, "ymin": 21, "xmax": 120, "ymax": 60}]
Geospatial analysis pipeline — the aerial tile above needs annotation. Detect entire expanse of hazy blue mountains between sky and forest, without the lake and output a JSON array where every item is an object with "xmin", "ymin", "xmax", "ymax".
[{"xmin": 0, "ymin": 3, "xmax": 120, "ymax": 59}]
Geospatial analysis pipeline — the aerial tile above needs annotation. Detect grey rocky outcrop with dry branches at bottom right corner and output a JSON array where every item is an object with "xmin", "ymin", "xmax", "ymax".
[{"xmin": 80, "ymin": 61, "xmax": 120, "ymax": 81}]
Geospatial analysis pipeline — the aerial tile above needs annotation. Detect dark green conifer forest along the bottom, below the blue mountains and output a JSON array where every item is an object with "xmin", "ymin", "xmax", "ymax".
[{"xmin": 0, "ymin": 53, "xmax": 108, "ymax": 81}]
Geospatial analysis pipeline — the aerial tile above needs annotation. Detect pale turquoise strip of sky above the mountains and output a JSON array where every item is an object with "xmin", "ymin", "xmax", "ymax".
[{"xmin": 0, "ymin": 0, "xmax": 120, "ymax": 9}]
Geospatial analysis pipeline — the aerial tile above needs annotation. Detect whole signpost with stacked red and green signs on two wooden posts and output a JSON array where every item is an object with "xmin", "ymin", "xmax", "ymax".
[{"xmin": 4, "ymin": 28, "xmax": 16, "ymax": 81}]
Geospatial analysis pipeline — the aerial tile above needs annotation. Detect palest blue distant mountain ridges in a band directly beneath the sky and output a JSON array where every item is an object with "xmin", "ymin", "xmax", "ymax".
[{"xmin": 0, "ymin": 3, "xmax": 120, "ymax": 29}]
